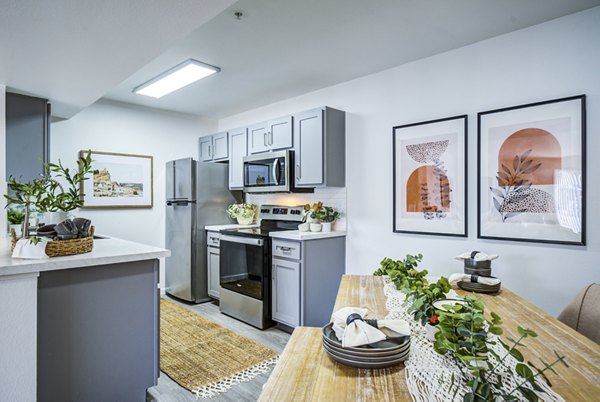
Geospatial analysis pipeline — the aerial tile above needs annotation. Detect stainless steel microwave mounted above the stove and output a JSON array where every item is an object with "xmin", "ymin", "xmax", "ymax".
[{"xmin": 244, "ymin": 150, "xmax": 314, "ymax": 193}]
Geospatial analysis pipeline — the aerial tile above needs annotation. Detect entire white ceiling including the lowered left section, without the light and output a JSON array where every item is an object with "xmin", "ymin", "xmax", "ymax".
[{"xmin": 0, "ymin": 0, "xmax": 600, "ymax": 118}]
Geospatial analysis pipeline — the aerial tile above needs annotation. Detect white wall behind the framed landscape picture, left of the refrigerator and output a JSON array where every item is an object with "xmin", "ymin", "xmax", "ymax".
[{"xmin": 50, "ymin": 101, "xmax": 216, "ymax": 283}]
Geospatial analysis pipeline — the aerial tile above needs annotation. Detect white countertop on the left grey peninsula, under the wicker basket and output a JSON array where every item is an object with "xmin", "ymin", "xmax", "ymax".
[{"xmin": 0, "ymin": 238, "xmax": 171, "ymax": 277}]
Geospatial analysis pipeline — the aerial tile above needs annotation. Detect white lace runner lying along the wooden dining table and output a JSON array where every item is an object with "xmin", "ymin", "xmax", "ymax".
[{"xmin": 384, "ymin": 278, "xmax": 564, "ymax": 402}]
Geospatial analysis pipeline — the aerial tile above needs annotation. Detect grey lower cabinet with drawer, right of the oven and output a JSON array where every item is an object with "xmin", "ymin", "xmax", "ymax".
[{"xmin": 271, "ymin": 236, "xmax": 346, "ymax": 328}]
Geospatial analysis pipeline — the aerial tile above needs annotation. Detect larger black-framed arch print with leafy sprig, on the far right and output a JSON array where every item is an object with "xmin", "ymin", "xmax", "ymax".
[{"xmin": 477, "ymin": 95, "xmax": 585, "ymax": 245}]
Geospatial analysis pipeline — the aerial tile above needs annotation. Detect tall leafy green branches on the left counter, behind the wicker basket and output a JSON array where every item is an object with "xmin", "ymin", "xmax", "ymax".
[{"xmin": 4, "ymin": 151, "xmax": 92, "ymax": 237}]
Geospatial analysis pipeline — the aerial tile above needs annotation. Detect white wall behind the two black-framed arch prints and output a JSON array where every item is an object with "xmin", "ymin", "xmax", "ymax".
[{"xmin": 219, "ymin": 7, "xmax": 600, "ymax": 314}]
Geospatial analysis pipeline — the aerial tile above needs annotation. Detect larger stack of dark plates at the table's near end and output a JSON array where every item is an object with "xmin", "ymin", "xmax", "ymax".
[{"xmin": 323, "ymin": 323, "xmax": 410, "ymax": 369}]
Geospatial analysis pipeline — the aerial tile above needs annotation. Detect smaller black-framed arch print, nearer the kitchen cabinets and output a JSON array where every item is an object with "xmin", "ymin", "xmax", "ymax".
[{"xmin": 392, "ymin": 115, "xmax": 467, "ymax": 237}]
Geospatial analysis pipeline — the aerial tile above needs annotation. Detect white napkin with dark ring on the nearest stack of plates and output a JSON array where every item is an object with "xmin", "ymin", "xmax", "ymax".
[{"xmin": 333, "ymin": 307, "xmax": 410, "ymax": 347}]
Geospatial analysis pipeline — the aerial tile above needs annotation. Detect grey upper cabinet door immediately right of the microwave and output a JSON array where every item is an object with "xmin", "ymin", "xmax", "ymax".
[{"xmin": 294, "ymin": 109, "xmax": 322, "ymax": 186}]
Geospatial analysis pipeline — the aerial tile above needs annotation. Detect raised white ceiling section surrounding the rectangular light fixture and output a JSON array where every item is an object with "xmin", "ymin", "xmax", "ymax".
[{"xmin": 107, "ymin": 0, "xmax": 600, "ymax": 118}]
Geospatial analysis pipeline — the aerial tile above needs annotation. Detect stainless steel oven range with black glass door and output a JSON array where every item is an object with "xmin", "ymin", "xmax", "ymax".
[{"xmin": 219, "ymin": 205, "xmax": 304, "ymax": 329}]
